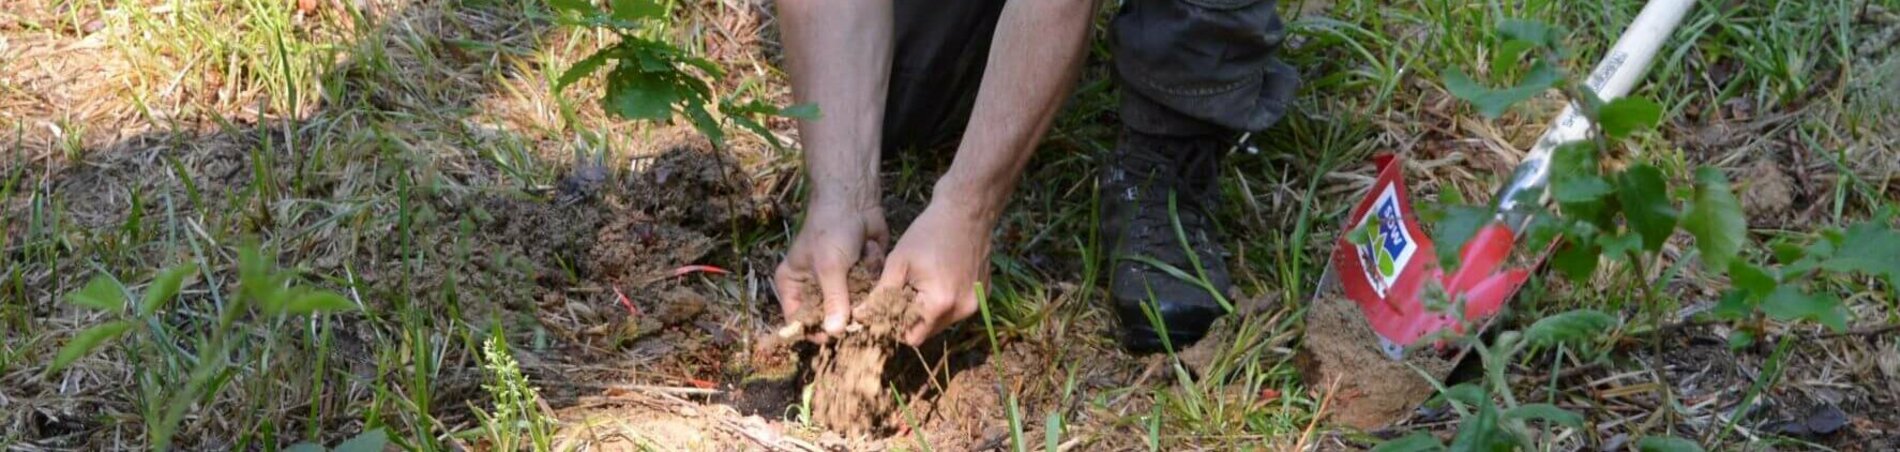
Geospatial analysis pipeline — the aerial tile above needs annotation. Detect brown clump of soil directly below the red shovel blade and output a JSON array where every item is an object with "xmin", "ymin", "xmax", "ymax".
[{"xmin": 1296, "ymin": 296, "xmax": 1455, "ymax": 429}]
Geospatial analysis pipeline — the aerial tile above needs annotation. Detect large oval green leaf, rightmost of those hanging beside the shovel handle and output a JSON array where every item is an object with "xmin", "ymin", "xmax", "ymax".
[{"xmin": 1682, "ymin": 167, "xmax": 1748, "ymax": 272}]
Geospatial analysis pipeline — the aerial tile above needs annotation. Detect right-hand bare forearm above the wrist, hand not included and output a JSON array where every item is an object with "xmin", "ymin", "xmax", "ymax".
[{"xmin": 935, "ymin": 0, "xmax": 1094, "ymax": 220}]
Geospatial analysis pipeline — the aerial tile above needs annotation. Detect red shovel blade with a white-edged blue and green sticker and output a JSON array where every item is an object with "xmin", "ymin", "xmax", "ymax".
[{"xmin": 1332, "ymin": 156, "xmax": 1530, "ymax": 357}]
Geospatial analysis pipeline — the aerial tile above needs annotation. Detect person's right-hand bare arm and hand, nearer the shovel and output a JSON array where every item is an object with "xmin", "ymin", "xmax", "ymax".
[{"xmin": 878, "ymin": 0, "xmax": 1094, "ymax": 344}]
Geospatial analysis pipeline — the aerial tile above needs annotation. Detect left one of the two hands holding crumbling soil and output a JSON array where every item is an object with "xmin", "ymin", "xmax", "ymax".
[{"xmin": 771, "ymin": 198, "xmax": 891, "ymax": 344}]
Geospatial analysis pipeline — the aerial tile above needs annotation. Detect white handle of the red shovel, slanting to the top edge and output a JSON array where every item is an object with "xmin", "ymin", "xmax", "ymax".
[{"xmin": 1495, "ymin": 0, "xmax": 1695, "ymax": 226}]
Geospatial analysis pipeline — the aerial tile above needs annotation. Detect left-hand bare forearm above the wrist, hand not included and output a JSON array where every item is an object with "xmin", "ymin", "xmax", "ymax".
[{"xmin": 777, "ymin": 0, "xmax": 891, "ymax": 209}]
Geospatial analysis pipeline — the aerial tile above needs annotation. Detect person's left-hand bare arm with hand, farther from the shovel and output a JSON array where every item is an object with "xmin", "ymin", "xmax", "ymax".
[{"xmin": 773, "ymin": 0, "xmax": 893, "ymax": 334}]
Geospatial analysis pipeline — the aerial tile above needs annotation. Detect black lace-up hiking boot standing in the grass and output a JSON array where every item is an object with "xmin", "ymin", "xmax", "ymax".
[{"xmin": 1100, "ymin": 129, "xmax": 1231, "ymax": 353}]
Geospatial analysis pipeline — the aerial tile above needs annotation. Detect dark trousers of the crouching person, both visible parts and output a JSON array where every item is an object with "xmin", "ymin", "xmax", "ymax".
[{"xmin": 884, "ymin": 0, "xmax": 1300, "ymax": 152}]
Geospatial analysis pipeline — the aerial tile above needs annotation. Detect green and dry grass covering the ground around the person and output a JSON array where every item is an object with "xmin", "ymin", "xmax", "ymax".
[{"xmin": 0, "ymin": 0, "xmax": 1900, "ymax": 450}]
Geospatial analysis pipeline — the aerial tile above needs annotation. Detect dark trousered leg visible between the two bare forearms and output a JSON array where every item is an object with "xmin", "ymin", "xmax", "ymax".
[{"xmin": 884, "ymin": 0, "xmax": 1003, "ymax": 154}]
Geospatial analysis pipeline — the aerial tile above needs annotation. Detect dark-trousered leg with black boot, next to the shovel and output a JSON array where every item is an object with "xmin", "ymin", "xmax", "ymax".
[{"xmin": 1100, "ymin": 0, "xmax": 1298, "ymax": 351}]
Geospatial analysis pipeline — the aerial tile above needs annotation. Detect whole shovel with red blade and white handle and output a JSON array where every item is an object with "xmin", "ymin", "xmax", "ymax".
[{"xmin": 1307, "ymin": 0, "xmax": 1695, "ymax": 424}]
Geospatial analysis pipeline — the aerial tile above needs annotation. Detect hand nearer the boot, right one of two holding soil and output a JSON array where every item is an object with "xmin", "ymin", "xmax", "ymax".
[{"xmin": 878, "ymin": 198, "xmax": 996, "ymax": 346}]
